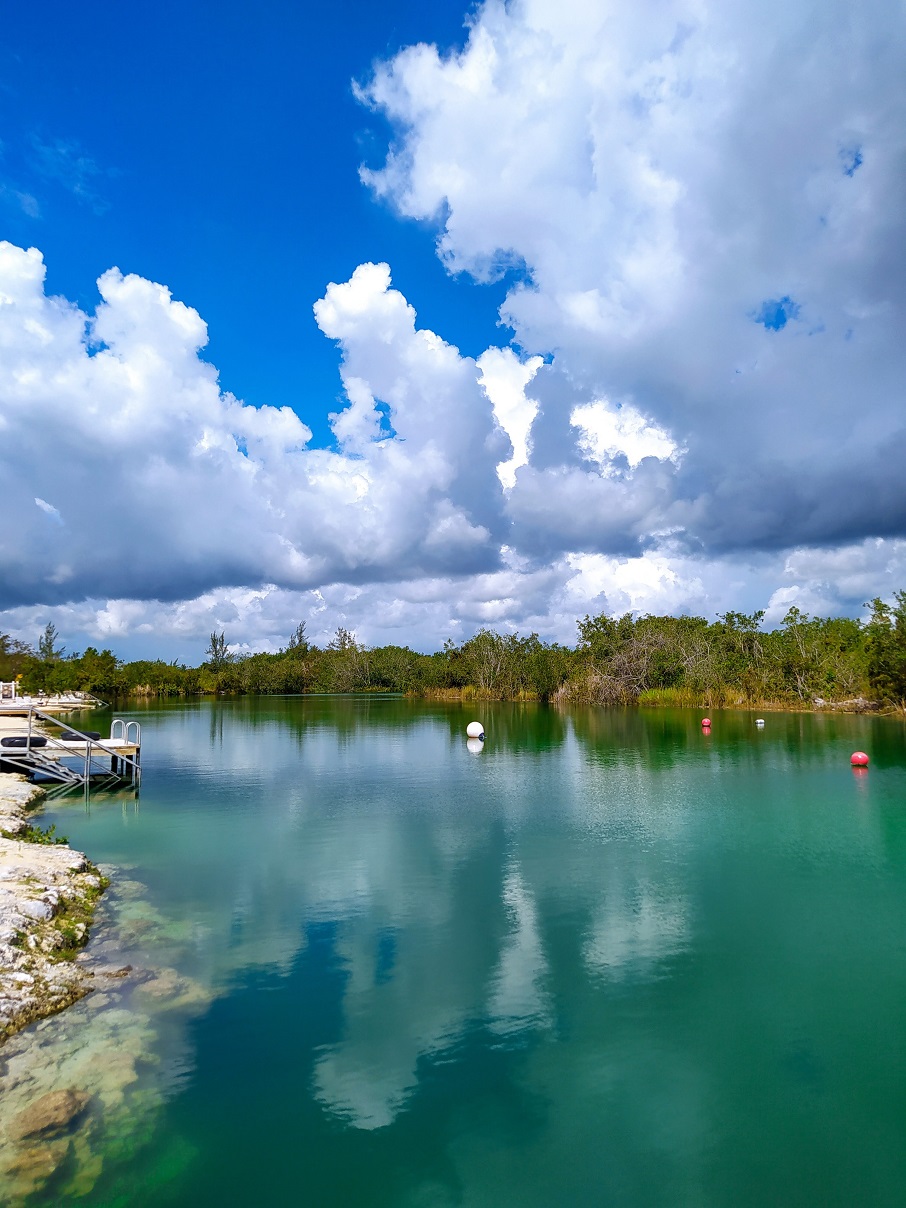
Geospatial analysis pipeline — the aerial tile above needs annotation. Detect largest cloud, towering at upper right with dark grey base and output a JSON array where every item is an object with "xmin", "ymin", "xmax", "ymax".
[{"xmin": 367, "ymin": 0, "xmax": 906, "ymax": 565}]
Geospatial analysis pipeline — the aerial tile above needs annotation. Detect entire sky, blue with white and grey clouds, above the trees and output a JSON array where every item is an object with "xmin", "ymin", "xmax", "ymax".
[{"xmin": 0, "ymin": 0, "xmax": 906, "ymax": 662}]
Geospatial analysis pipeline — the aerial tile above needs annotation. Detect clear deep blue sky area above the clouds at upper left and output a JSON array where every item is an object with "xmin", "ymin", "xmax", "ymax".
[{"xmin": 0, "ymin": 0, "xmax": 509, "ymax": 441}]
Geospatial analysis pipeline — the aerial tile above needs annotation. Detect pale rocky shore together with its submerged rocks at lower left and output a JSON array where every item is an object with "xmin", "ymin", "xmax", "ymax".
[{"xmin": 0, "ymin": 774, "xmax": 214, "ymax": 1208}]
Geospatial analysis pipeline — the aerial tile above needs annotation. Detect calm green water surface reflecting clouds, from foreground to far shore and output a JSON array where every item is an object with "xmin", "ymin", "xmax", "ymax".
[{"xmin": 5, "ymin": 697, "xmax": 906, "ymax": 1208}]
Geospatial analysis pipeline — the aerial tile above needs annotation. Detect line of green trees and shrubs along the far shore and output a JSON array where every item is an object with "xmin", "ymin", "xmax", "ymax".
[{"xmin": 0, "ymin": 592, "xmax": 906, "ymax": 708}]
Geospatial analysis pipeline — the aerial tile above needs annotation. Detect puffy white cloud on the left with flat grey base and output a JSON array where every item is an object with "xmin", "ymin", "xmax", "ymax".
[{"xmin": 0, "ymin": 254, "xmax": 511, "ymax": 608}]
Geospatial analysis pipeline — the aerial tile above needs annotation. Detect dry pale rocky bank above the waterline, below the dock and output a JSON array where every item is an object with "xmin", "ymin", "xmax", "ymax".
[{"xmin": 0, "ymin": 773, "xmax": 106, "ymax": 1044}]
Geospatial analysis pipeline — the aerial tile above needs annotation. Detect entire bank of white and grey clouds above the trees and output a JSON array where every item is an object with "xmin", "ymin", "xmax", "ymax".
[{"xmin": 0, "ymin": 0, "xmax": 906, "ymax": 645}]
